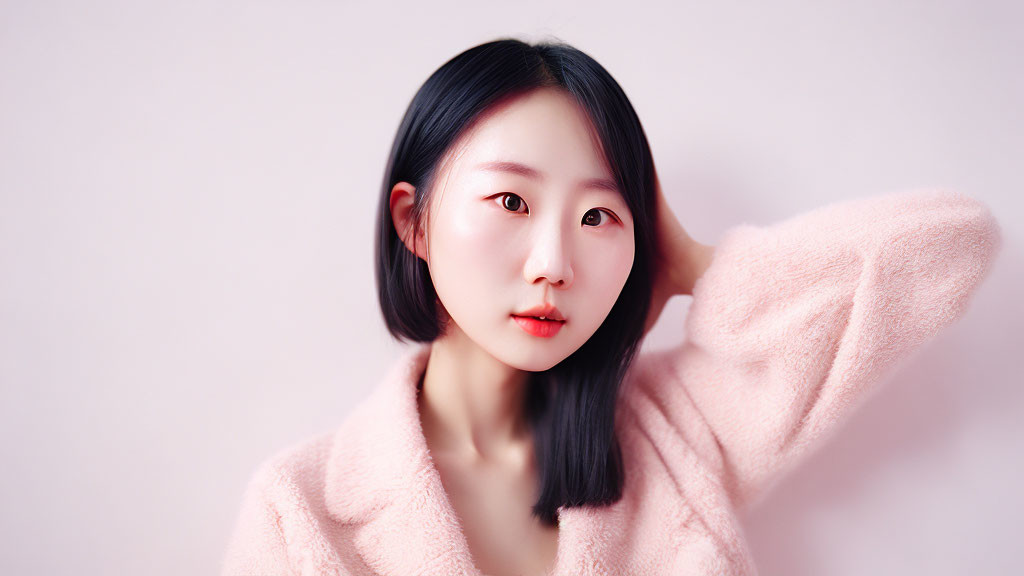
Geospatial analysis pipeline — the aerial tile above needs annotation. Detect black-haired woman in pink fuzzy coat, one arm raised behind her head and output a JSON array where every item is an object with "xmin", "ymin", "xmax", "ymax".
[{"xmin": 223, "ymin": 39, "xmax": 999, "ymax": 576}]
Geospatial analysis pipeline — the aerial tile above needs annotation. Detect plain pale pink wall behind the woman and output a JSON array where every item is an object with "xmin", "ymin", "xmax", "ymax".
[{"xmin": 0, "ymin": 0, "xmax": 1024, "ymax": 575}]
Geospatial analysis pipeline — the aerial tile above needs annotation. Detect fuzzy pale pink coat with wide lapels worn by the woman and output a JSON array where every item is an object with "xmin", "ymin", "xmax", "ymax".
[{"xmin": 222, "ymin": 190, "xmax": 1001, "ymax": 576}]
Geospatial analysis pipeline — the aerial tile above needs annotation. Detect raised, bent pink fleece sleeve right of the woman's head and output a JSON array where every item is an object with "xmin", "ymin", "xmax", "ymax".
[{"xmin": 647, "ymin": 190, "xmax": 1001, "ymax": 507}]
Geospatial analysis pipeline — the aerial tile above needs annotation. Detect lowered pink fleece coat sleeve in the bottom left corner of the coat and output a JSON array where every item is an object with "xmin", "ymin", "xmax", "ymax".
[{"xmin": 221, "ymin": 463, "xmax": 293, "ymax": 576}]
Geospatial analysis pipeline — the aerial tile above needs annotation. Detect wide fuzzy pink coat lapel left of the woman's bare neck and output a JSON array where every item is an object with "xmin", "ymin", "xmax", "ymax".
[{"xmin": 326, "ymin": 344, "xmax": 481, "ymax": 576}]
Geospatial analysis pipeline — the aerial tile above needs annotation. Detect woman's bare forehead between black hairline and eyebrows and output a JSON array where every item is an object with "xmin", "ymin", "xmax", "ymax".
[{"xmin": 445, "ymin": 88, "xmax": 611, "ymax": 184}]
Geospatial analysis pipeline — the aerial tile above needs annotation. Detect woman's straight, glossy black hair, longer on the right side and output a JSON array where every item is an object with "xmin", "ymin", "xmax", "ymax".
[{"xmin": 375, "ymin": 38, "xmax": 655, "ymax": 526}]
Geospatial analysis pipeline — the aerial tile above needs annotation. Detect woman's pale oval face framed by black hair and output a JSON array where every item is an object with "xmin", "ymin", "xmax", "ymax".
[{"xmin": 426, "ymin": 89, "xmax": 634, "ymax": 371}]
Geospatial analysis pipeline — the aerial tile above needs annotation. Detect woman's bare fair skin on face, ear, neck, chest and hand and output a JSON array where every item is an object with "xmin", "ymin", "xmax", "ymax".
[{"xmin": 390, "ymin": 88, "xmax": 714, "ymax": 576}]
